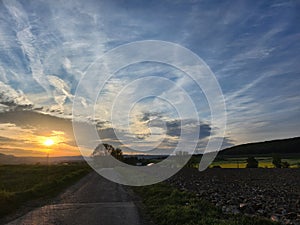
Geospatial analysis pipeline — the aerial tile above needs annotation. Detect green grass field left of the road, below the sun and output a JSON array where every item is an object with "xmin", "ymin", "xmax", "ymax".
[{"xmin": 0, "ymin": 163, "xmax": 90, "ymax": 218}]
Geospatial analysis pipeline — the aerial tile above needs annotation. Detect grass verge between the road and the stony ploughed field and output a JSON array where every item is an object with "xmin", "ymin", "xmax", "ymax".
[{"xmin": 133, "ymin": 183, "xmax": 277, "ymax": 225}]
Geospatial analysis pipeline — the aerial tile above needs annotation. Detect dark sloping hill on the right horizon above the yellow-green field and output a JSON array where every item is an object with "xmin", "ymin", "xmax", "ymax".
[{"xmin": 219, "ymin": 137, "xmax": 300, "ymax": 156}]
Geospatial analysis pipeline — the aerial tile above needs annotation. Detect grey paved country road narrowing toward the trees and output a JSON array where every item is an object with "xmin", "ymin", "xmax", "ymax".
[{"xmin": 8, "ymin": 172, "xmax": 144, "ymax": 225}]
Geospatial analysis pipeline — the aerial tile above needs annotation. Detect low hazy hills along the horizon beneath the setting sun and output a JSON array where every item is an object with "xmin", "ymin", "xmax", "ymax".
[{"xmin": 0, "ymin": 153, "xmax": 84, "ymax": 165}]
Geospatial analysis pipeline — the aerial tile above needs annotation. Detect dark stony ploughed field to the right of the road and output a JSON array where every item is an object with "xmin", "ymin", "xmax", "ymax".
[{"xmin": 168, "ymin": 168, "xmax": 300, "ymax": 225}]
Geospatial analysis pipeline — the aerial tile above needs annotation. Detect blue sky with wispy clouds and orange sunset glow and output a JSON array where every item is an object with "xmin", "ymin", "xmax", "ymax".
[{"xmin": 0, "ymin": 0, "xmax": 300, "ymax": 156}]
